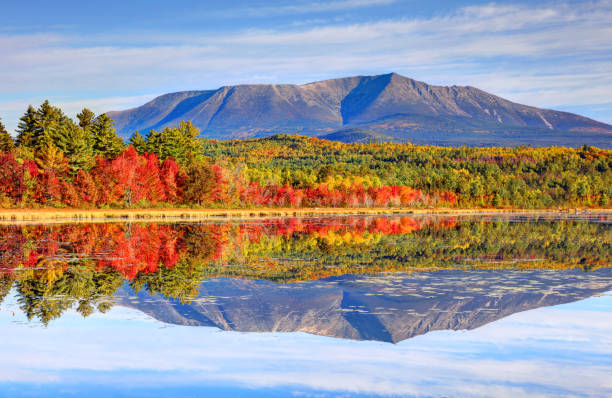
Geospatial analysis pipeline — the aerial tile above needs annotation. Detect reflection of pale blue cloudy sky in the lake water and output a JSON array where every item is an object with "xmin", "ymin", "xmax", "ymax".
[{"xmin": 0, "ymin": 295, "xmax": 612, "ymax": 396}]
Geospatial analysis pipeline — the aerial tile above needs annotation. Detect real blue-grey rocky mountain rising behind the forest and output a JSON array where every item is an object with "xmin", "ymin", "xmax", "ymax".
[{"xmin": 108, "ymin": 73, "xmax": 612, "ymax": 147}]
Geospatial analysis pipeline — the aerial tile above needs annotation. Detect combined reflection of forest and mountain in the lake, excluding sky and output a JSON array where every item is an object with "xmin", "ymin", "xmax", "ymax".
[{"xmin": 0, "ymin": 215, "xmax": 612, "ymax": 342}]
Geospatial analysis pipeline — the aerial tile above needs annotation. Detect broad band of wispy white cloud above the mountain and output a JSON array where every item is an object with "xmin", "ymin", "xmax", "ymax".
[{"xmin": 0, "ymin": 0, "xmax": 612, "ymax": 128}]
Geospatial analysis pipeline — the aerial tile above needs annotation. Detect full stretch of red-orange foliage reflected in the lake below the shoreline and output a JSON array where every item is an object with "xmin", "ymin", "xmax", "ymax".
[{"xmin": 0, "ymin": 217, "xmax": 454, "ymax": 280}]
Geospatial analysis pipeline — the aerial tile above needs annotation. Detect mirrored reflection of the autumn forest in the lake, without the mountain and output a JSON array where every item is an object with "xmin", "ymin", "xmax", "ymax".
[{"xmin": 0, "ymin": 217, "xmax": 612, "ymax": 324}]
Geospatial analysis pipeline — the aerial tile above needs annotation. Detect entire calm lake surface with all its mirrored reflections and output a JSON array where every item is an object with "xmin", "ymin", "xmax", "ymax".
[{"xmin": 0, "ymin": 214, "xmax": 612, "ymax": 397}]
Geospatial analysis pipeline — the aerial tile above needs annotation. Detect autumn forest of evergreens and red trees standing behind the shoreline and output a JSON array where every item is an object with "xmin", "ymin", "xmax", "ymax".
[{"xmin": 0, "ymin": 101, "xmax": 612, "ymax": 209}]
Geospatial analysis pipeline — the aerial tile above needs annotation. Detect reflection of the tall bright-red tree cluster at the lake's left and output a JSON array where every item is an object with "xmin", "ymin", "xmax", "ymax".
[{"xmin": 0, "ymin": 224, "xmax": 182, "ymax": 279}]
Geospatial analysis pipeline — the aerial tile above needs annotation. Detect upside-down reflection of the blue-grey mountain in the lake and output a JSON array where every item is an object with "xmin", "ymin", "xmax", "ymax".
[{"xmin": 116, "ymin": 268, "xmax": 612, "ymax": 343}]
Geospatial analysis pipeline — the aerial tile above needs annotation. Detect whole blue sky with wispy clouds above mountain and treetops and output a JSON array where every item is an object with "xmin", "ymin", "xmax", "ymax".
[{"xmin": 0, "ymin": 0, "xmax": 612, "ymax": 134}]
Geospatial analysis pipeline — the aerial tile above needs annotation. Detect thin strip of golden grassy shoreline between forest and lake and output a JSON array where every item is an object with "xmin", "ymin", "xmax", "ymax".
[{"xmin": 0, "ymin": 207, "xmax": 612, "ymax": 224}]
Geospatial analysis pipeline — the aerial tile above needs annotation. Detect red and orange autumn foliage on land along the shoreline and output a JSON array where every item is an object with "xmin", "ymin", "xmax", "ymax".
[{"xmin": 0, "ymin": 146, "xmax": 444, "ymax": 208}]
